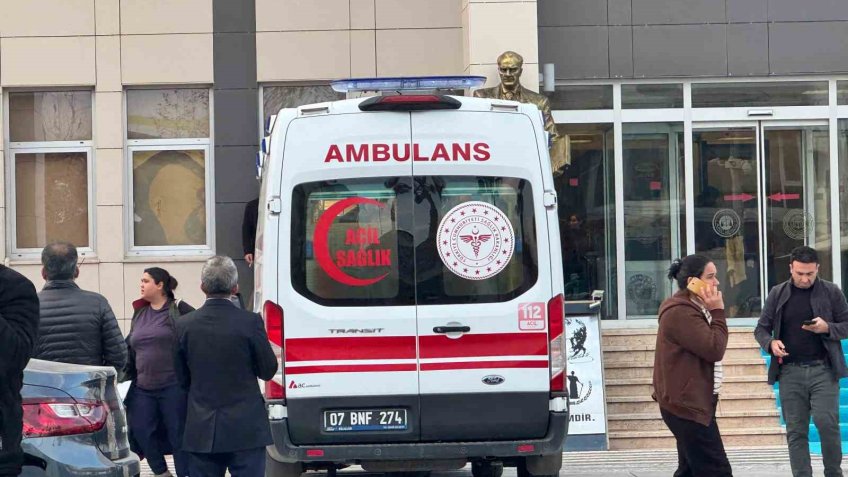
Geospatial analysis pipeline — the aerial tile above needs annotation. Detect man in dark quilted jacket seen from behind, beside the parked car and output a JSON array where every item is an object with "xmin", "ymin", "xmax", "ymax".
[{"xmin": 33, "ymin": 242, "xmax": 127, "ymax": 373}]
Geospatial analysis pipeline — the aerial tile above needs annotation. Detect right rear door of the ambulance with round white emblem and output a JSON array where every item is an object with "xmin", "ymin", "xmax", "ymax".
[{"xmin": 412, "ymin": 110, "xmax": 553, "ymax": 441}]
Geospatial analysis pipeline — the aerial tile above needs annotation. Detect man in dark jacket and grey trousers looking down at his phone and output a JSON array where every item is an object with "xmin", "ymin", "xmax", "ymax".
[{"xmin": 754, "ymin": 247, "xmax": 848, "ymax": 477}]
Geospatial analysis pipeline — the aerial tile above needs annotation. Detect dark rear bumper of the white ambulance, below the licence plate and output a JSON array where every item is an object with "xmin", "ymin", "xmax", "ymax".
[{"xmin": 267, "ymin": 412, "xmax": 568, "ymax": 463}]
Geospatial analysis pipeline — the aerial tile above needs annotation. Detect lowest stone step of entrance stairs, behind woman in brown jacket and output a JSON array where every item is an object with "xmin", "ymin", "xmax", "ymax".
[{"xmin": 609, "ymin": 426, "xmax": 786, "ymax": 450}]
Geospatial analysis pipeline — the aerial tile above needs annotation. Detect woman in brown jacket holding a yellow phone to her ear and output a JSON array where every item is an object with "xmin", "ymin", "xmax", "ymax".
[{"xmin": 653, "ymin": 255, "xmax": 733, "ymax": 477}]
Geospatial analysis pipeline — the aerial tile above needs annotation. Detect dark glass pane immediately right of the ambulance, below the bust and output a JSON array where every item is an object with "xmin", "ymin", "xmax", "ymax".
[{"xmin": 554, "ymin": 124, "xmax": 618, "ymax": 319}]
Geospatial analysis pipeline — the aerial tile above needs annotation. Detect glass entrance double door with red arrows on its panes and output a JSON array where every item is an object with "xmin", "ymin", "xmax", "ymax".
[{"xmin": 692, "ymin": 121, "xmax": 831, "ymax": 318}]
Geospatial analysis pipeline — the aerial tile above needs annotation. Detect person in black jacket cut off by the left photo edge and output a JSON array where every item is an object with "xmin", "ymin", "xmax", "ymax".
[{"xmin": 0, "ymin": 265, "xmax": 38, "ymax": 477}]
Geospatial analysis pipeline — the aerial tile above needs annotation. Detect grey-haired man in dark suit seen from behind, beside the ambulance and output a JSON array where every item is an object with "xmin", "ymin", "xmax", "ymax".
[{"xmin": 177, "ymin": 256, "xmax": 277, "ymax": 477}]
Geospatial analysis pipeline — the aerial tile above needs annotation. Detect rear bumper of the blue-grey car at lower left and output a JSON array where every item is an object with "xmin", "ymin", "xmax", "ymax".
[{"xmin": 21, "ymin": 436, "xmax": 141, "ymax": 477}]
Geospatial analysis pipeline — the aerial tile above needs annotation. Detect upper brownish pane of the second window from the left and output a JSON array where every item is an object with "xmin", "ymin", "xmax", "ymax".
[{"xmin": 127, "ymin": 88, "xmax": 209, "ymax": 139}]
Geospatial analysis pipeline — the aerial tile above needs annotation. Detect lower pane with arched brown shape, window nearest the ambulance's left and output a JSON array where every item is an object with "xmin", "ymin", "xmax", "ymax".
[{"xmin": 132, "ymin": 149, "xmax": 207, "ymax": 247}]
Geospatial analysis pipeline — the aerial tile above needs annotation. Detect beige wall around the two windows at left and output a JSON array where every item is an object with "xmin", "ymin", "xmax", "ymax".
[{"xmin": 0, "ymin": 0, "xmax": 213, "ymax": 327}]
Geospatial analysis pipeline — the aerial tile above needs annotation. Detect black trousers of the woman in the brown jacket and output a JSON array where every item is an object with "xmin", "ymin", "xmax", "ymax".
[{"xmin": 660, "ymin": 396, "xmax": 733, "ymax": 477}]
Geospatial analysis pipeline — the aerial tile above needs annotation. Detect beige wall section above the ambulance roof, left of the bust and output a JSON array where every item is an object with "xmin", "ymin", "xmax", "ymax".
[{"xmin": 256, "ymin": 0, "xmax": 465, "ymax": 82}]
